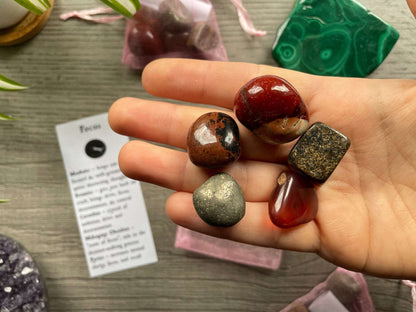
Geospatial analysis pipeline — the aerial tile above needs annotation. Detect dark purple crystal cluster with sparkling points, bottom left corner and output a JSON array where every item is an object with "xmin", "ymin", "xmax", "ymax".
[{"xmin": 0, "ymin": 235, "xmax": 47, "ymax": 312}]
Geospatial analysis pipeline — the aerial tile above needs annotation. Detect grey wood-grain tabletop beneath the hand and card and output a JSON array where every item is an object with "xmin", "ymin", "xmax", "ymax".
[{"xmin": 0, "ymin": 0, "xmax": 416, "ymax": 312}]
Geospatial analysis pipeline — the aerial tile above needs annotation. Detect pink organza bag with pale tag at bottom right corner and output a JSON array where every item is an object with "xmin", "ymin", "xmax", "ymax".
[{"xmin": 281, "ymin": 268, "xmax": 375, "ymax": 312}]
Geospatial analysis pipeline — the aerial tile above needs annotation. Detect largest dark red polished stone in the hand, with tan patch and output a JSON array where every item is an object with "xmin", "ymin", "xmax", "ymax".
[{"xmin": 234, "ymin": 75, "xmax": 309, "ymax": 144}]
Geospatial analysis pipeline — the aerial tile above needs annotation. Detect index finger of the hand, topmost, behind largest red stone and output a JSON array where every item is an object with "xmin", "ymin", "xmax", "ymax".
[{"xmin": 142, "ymin": 59, "xmax": 319, "ymax": 109}]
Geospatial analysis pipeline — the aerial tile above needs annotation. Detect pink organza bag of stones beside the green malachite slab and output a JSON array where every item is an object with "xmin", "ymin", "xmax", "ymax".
[{"xmin": 122, "ymin": 0, "xmax": 228, "ymax": 69}]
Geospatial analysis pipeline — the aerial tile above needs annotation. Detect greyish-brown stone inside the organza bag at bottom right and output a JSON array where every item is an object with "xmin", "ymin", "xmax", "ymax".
[{"xmin": 327, "ymin": 271, "xmax": 361, "ymax": 306}]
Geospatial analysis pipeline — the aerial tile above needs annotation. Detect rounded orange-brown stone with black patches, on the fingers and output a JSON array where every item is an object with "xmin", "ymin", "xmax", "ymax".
[{"xmin": 187, "ymin": 112, "xmax": 240, "ymax": 168}]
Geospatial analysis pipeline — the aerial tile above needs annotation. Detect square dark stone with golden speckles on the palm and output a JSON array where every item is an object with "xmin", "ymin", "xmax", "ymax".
[{"xmin": 288, "ymin": 122, "xmax": 351, "ymax": 183}]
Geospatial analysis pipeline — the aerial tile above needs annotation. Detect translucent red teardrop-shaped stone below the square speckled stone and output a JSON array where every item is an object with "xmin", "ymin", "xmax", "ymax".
[{"xmin": 269, "ymin": 170, "xmax": 318, "ymax": 228}]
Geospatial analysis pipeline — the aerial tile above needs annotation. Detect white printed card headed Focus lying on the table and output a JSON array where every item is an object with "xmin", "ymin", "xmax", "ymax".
[{"xmin": 56, "ymin": 114, "xmax": 157, "ymax": 277}]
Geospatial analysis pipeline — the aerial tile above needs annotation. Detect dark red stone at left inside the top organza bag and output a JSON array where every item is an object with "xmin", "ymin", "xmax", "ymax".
[{"xmin": 127, "ymin": 24, "xmax": 164, "ymax": 56}]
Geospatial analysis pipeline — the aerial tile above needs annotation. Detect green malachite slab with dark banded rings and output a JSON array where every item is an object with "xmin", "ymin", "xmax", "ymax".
[{"xmin": 272, "ymin": 0, "xmax": 399, "ymax": 77}]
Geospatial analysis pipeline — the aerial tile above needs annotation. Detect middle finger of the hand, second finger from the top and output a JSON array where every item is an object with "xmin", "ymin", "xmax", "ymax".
[{"xmin": 109, "ymin": 98, "xmax": 292, "ymax": 162}]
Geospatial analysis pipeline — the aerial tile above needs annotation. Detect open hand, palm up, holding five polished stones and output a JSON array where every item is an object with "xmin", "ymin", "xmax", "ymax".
[{"xmin": 109, "ymin": 59, "xmax": 416, "ymax": 279}]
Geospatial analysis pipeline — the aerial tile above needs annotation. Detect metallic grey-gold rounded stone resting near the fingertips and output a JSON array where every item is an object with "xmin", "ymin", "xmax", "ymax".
[{"xmin": 193, "ymin": 173, "xmax": 246, "ymax": 227}]
